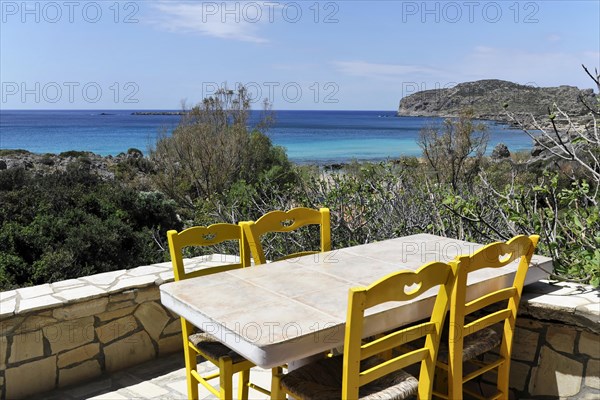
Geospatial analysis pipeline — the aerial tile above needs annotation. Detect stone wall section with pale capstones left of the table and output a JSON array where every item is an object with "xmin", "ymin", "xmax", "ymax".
[{"xmin": 0, "ymin": 255, "xmax": 238, "ymax": 399}]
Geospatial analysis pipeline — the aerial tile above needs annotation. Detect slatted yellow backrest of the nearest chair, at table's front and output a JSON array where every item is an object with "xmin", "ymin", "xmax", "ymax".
[{"xmin": 342, "ymin": 262, "xmax": 455, "ymax": 399}]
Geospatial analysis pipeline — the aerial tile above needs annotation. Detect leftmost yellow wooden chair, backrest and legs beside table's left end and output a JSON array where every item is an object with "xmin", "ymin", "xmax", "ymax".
[{"xmin": 167, "ymin": 223, "xmax": 269, "ymax": 400}]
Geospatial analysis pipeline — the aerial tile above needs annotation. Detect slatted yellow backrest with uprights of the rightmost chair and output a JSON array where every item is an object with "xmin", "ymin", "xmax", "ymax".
[{"xmin": 448, "ymin": 235, "xmax": 539, "ymax": 398}]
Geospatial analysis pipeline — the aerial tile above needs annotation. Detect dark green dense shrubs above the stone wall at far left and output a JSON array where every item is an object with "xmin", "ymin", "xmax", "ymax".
[{"xmin": 0, "ymin": 167, "xmax": 181, "ymax": 290}]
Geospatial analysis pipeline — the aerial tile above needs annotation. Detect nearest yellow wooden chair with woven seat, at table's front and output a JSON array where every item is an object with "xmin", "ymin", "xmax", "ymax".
[{"xmin": 273, "ymin": 262, "xmax": 455, "ymax": 400}]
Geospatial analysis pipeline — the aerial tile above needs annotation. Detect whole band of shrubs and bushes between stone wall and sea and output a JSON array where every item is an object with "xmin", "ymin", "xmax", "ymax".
[{"xmin": 0, "ymin": 70, "xmax": 600, "ymax": 290}]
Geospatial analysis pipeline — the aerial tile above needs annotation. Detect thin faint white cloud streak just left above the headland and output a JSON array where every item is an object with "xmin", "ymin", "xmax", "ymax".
[{"xmin": 333, "ymin": 61, "xmax": 440, "ymax": 79}]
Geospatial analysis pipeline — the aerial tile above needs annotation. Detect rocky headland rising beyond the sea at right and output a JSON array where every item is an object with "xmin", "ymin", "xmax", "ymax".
[{"xmin": 398, "ymin": 79, "xmax": 598, "ymax": 162}]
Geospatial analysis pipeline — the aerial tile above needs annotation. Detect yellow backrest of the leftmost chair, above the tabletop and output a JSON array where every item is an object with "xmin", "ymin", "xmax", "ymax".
[{"xmin": 167, "ymin": 223, "xmax": 250, "ymax": 281}]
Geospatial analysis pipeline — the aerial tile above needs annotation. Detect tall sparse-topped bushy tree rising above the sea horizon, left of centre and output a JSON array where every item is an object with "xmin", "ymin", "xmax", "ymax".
[{"xmin": 151, "ymin": 86, "xmax": 291, "ymax": 208}]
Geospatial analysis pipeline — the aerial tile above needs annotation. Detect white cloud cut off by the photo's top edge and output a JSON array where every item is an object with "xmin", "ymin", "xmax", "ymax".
[{"xmin": 149, "ymin": 1, "xmax": 267, "ymax": 43}]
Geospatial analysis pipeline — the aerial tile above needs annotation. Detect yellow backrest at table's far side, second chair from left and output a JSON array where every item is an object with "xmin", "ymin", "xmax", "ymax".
[{"xmin": 240, "ymin": 207, "xmax": 331, "ymax": 264}]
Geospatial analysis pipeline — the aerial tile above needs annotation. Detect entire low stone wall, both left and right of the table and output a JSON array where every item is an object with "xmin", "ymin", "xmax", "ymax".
[{"xmin": 0, "ymin": 262, "xmax": 600, "ymax": 399}]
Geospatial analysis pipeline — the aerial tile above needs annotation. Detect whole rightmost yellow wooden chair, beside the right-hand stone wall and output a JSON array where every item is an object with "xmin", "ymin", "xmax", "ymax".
[{"xmin": 446, "ymin": 235, "xmax": 539, "ymax": 399}]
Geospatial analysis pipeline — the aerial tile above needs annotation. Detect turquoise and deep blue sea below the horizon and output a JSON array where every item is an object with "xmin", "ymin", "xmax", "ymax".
[{"xmin": 0, "ymin": 110, "xmax": 532, "ymax": 164}]
